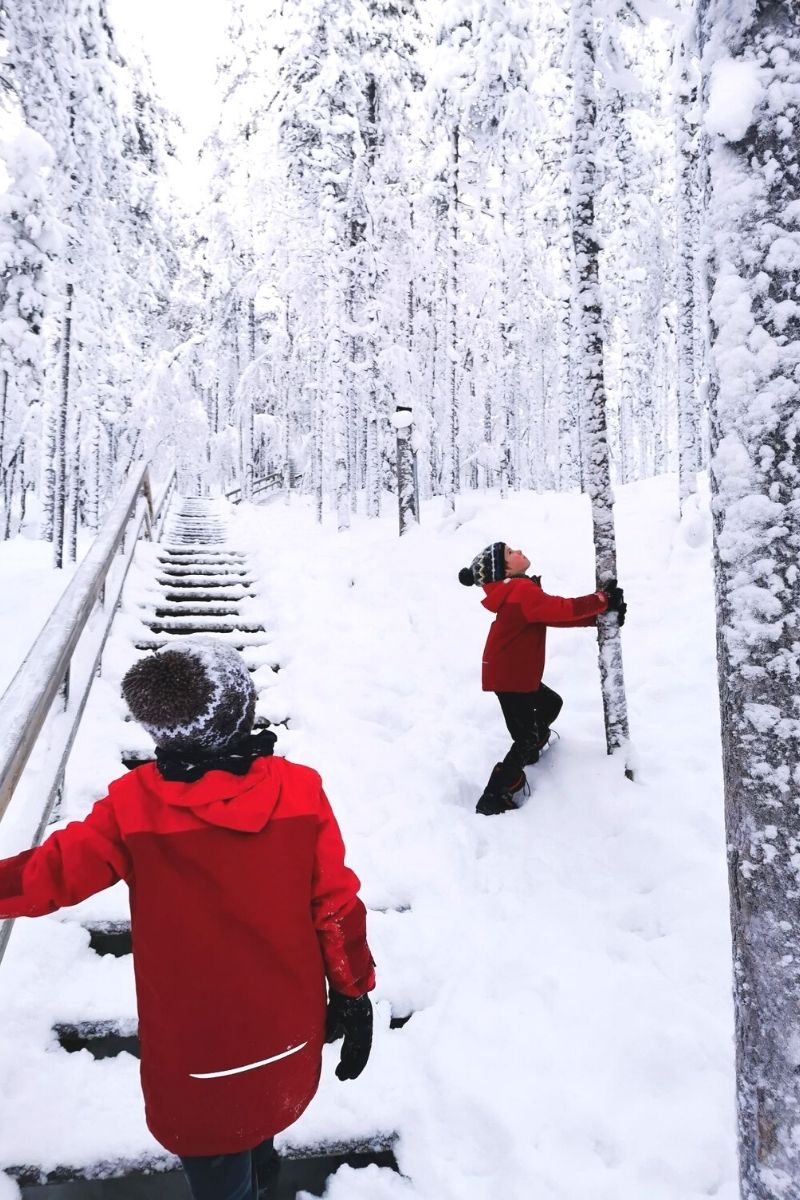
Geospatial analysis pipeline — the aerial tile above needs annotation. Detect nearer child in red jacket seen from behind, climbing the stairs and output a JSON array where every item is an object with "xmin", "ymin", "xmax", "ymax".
[{"xmin": 0, "ymin": 637, "xmax": 375, "ymax": 1200}]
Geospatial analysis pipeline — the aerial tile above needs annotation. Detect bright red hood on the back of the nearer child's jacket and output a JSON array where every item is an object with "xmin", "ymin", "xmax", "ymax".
[{"xmin": 138, "ymin": 757, "xmax": 283, "ymax": 833}]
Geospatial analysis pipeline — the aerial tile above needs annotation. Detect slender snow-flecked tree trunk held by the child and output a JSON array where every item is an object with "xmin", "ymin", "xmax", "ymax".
[{"xmin": 572, "ymin": 0, "xmax": 628, "ymax": 754}]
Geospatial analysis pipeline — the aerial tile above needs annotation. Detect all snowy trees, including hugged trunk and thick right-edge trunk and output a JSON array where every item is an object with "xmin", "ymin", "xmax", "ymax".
[{"xmin": 0, "ymin": 0, "xmax": 800, "ymax": 1200}]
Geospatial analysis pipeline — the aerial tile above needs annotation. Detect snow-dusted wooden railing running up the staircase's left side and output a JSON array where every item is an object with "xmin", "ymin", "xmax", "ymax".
[{"xmin": 0, "ymin": 464, "xmax": 174, "ymax": 836}]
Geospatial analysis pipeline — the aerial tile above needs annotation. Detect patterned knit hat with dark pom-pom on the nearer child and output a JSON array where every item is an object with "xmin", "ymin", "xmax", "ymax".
[{"xmin": 122, "ymin": 637, "xmax": 255, "ymax": 750}]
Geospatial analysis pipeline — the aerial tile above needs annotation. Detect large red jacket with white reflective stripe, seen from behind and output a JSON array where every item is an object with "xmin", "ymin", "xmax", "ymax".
[{"xmin": 0, "ymin": 758, "xmax": 374, "ymax": 1154}]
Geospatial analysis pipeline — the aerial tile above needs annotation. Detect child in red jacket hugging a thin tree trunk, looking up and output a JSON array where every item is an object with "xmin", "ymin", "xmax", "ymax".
[{"xmin": 458, "ymin": 541, "xmax": 626, "ymax": 816}]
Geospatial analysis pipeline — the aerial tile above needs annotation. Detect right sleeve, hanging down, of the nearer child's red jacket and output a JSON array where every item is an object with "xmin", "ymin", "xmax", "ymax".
[{"xmin": 312, "ymin": 792, "xmax": 375, "ymax": 996}]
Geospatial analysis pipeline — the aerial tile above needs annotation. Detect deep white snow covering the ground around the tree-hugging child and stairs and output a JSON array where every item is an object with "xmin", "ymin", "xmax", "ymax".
[{"xmin": 0, "ymin": 479, "xmax": 736, "ymax": 1200}]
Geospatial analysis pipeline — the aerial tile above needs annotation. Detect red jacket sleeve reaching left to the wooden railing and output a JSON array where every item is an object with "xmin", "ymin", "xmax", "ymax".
[{"xmin": 0, "ymin": 798, "xmax": 131, "ymax": 918}]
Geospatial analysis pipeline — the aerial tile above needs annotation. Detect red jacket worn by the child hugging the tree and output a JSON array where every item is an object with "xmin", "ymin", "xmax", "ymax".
[{"xmin": 481, "ymin": 575, "xmax": 608, "ymax": 691}]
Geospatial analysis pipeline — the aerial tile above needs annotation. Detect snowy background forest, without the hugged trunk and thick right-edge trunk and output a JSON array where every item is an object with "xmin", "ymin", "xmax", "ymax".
[{"xmin": 0, "ymin": 0, "xmax": 706, "ymax": 553}]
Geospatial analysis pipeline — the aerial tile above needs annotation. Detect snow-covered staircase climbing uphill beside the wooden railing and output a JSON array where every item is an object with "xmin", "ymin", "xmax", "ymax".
[{"xmin": 0, "ymin": 499, "xmax": 398, "ymax": 1200}]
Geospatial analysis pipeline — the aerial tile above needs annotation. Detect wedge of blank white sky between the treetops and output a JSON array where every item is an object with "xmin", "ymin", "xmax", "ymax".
[{"xmin": 109, "ymin": 0, "xmax": 230, "ymax": 150}]
